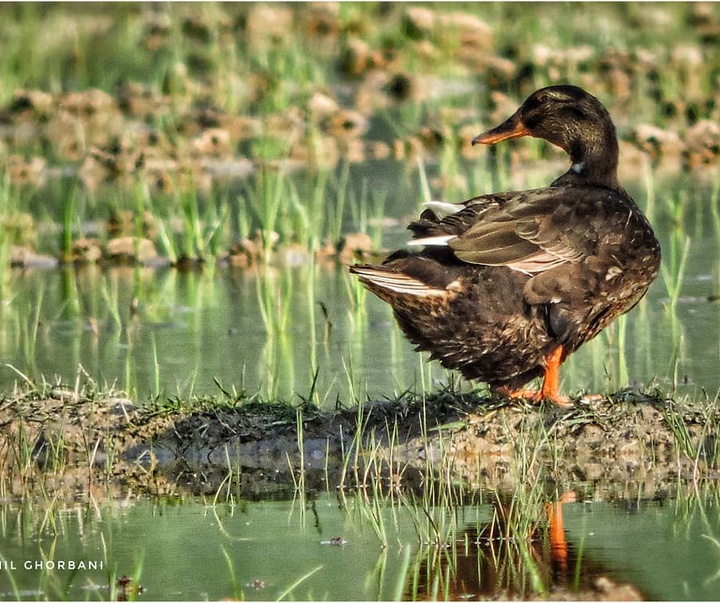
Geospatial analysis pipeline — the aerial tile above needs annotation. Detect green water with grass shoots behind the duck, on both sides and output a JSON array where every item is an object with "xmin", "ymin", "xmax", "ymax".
[{"xmin": 0, "ymin": 225, "xmax": 720, "ymax": 407}]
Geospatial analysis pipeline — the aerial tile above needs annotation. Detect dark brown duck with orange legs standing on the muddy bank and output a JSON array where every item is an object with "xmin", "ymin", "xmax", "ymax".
[{"xmin": 349, "ymin": 84, "xmax": 661, "ymax": 408}]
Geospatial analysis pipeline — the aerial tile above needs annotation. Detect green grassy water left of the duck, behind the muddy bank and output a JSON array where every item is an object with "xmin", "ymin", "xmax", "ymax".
[{"xmin": 0, "ymin": 266, "xmax": 450, "ymax": 405}]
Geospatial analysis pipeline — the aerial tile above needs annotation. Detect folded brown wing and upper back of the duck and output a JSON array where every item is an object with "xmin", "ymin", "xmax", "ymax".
[{"xmin": 412, "ymin": 187, "xmax": 657, "ymax": 312}]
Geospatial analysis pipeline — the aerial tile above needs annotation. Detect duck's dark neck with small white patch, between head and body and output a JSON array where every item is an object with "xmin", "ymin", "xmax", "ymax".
[{"xmin": 553, "ymin": 131, "xmax": 622, "ymax": 189}]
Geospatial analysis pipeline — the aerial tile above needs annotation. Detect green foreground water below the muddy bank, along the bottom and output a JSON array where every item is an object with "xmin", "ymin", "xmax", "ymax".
[{"xmin": 0, "ymin": 494, "xmax": 720, "ymax": 600}]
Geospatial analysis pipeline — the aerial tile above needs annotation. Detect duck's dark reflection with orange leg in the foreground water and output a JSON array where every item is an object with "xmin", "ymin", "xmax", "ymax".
[{"xmin": 405, "ymin": 492, "xmax": 643, "ymax": 601}]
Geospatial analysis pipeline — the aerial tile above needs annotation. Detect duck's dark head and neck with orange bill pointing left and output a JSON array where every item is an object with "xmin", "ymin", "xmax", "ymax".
[{"xmin": 472, "ymin": 85, "xmax": 618, "ymax": 184}]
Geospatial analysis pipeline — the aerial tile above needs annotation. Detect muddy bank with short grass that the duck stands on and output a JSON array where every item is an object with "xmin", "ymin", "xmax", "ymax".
[{"xmin": 0, "ymin": 389, "xmax": 720, "ymax": 497}]
